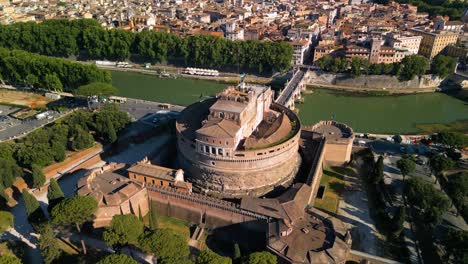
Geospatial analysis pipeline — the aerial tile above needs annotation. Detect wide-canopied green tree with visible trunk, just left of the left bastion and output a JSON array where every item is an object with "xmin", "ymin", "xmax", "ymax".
[{"xmin": 51, "ymin": 195, "xmax": 98, "ymax": 254}]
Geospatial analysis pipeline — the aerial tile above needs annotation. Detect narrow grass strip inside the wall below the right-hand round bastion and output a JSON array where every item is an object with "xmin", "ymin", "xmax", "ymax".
[{"xmin": 314, "ymin": 167, "xmax": 347, "ymax": 214}]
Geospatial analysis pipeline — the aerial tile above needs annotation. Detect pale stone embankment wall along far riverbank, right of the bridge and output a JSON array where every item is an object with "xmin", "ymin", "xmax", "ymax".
[{"xmin": 308, "ymin": 71, "xmax": 443, "ymax": 90}]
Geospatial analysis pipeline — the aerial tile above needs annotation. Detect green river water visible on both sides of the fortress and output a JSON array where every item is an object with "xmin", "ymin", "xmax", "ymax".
[{"xmin": 112, "ymin": 72, "xmax": 468, "ymax": 133}]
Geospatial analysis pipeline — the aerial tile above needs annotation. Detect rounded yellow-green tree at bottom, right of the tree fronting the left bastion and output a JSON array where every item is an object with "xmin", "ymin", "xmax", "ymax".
[{"xmin": 140, "ymin": 229, "xmax": 190, "ymax": 262}]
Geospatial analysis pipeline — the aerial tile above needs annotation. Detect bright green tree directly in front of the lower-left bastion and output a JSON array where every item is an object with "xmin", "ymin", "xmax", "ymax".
[{"xmin": 103, "ymin": 214, "xmax": 144, "ymax": 248}]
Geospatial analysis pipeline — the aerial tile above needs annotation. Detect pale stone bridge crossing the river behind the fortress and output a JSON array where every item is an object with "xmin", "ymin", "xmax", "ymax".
[{"xmin": 276, "ymin": 69, "xmax": 309, "ymax": 109}]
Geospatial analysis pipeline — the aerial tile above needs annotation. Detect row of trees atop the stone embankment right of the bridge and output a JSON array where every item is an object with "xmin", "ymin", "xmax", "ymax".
[{"xmin": 317, "ymin": 55, "xmax": 456, "ymax": 80}]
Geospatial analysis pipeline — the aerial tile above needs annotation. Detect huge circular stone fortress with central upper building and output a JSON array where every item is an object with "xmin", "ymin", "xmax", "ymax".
[{"xmin": 176, "ymin": 83, "xmax": 301, "ymax": 198}]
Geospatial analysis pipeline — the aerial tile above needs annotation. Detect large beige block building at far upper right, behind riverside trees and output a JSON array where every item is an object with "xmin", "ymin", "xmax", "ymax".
[{"xmin": 411, "ymin": 28, "xmax": 459, "ymax": 60}]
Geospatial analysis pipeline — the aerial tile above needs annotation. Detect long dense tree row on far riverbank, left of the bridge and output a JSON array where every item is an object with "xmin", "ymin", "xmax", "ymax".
[{"xmin": 0, "ymin": 19, "xmax": 293, "ymax": 72}]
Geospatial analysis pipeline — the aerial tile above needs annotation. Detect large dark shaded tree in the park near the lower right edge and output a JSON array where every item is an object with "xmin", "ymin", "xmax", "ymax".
[{"xmin": 407, "ymin": 178, "xmax": 450, "ymax": 226}]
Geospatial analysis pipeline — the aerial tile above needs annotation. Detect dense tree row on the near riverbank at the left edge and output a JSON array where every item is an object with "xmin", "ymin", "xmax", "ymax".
[{"xmin": 0, "ymin": 47, "xmax": 111, "ymax": 91}]
